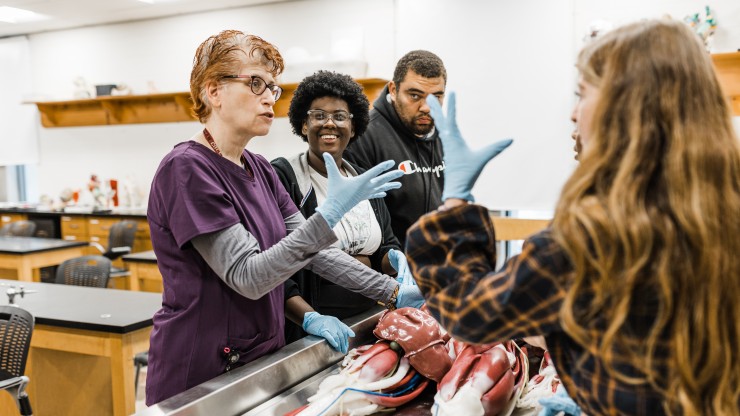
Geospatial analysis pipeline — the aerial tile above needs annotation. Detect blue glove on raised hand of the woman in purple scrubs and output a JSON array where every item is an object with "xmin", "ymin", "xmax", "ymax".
[{"xmin": 316, "ymin": 153, "xmax": 403, "ymax": 228}]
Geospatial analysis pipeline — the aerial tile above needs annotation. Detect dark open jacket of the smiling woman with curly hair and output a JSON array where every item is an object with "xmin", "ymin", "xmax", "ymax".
[{"xmin": 270, "ymin": 153, "xmax": 400, "ymax": 343}]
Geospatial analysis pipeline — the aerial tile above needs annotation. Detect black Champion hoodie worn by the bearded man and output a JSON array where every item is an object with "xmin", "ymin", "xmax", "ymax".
[{"xmin": 343, "ymin": 85, "xmax": 445, "ymax": 247}]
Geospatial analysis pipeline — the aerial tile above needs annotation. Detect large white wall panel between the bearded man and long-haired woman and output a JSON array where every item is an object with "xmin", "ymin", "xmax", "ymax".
[{"xmin": 398, "ymin": 0, "xmax": 575, "ymax": 209}]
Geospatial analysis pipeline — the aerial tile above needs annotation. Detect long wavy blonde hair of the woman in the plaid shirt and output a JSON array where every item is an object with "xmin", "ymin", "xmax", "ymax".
[{"xmin": 553, "ymin": 20, "xmax": 740, "ymax": 415}]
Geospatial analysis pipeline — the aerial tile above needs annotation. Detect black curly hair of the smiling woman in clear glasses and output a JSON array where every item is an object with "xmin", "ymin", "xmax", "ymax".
[{"xmin": 288, "ymin": 70, "xmax": 370, "ymax": 142}]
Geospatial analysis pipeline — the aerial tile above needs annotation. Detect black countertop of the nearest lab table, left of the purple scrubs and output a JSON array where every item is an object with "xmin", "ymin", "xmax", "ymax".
[{"xmin": 0, "ymin": 280, "xmax": 162, "ymax": 334}]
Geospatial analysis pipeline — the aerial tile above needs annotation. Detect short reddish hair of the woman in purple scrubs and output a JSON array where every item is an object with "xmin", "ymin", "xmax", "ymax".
[{"xmin": 190, "ymin": 30, "xmax": 285, "ymax": 123}]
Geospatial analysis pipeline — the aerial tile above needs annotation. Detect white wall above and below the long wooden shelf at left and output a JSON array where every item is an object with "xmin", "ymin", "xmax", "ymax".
[{"xmin": 30, "ymin": 0, "xmax": 396, "ymax": 205}]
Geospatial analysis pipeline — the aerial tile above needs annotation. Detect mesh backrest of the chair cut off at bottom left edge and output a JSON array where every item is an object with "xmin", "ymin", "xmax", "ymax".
[{"xmin": 0, "ymin": 305, "xmax": 33, "ymax": 380}]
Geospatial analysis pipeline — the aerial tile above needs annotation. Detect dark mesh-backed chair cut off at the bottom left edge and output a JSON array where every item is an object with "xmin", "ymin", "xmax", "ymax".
[{"xmin": 0, "ymin": 305, "xmax": 33, "ymax": 415}]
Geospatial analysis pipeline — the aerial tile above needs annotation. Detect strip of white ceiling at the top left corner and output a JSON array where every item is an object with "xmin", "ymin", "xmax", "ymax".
[{"xmin": 0, "ymin": 0, "xmax": 288, "ymax": 38}]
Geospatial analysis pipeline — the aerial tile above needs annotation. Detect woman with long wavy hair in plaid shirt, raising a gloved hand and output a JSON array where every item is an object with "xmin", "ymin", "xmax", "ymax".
[{"xmin": 407, "ymin": 20, "xmax": 740, "ymax": 416}]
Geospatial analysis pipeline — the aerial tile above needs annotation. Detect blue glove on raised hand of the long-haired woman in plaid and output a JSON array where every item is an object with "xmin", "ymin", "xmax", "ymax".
[{"xmin": 427, "ymin": 92, "xmax": 513, "ymax": 201}]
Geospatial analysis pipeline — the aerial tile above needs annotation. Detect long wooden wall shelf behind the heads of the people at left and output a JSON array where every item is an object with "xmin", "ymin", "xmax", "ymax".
[{"xmin": 30, "ymin": 78, "xmax": 388, "ymax": 127}]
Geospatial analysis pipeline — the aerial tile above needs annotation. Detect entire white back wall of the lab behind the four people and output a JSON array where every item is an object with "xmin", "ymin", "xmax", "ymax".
[{"xmin": 15, "ymin": 0, "xmax": 740, "ymax": 209}]
